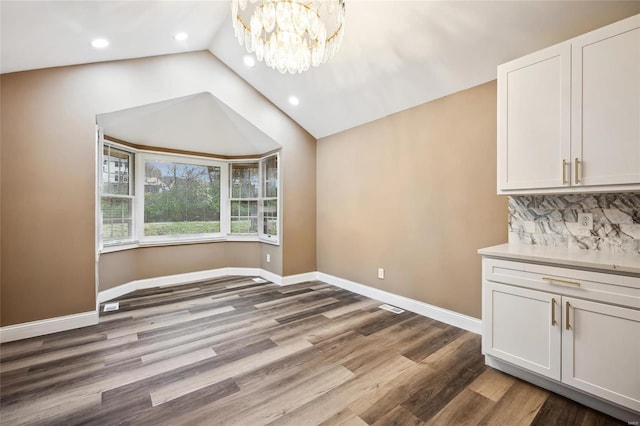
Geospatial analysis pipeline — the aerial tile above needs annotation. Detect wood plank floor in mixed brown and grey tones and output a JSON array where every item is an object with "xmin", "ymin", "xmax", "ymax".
[{"xmin": 0, "ymin": 277, "xmax": 620, "ymax": 426}]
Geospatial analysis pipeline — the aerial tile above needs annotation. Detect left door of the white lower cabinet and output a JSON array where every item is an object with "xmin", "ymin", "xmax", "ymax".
[{"xmin": 482, "ymin": 282, "xmax": 561, "ymax": 380}]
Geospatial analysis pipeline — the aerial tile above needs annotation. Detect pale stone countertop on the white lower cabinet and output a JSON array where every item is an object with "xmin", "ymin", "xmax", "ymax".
[{"xmin": 478, "ymin": 243, "xmax": 640, "ymax": 277}]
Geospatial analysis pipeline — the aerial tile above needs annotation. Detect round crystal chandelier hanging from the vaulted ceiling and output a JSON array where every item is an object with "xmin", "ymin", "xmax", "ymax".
[{"xmin": 231, "ymin": 0, "xmax": 345, "ymax": 74}]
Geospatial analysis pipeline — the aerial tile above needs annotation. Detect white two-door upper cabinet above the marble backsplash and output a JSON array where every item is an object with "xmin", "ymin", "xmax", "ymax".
[{"xmin": 498, "ymin": 15, "xmax": 640, "ymax": 194}]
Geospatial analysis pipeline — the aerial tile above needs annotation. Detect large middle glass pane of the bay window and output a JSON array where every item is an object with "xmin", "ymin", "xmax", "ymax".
[{"xmin": 144, "ymin": 160, "xmax": 220, "ymax": 236}]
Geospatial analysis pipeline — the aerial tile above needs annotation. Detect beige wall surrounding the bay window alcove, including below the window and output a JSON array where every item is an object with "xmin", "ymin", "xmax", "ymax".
[{"xmin": 0, "ymin": 51, "xmax": 316, "ymax": 326}]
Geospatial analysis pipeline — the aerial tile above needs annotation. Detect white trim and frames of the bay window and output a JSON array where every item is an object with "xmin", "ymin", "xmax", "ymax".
[{"xmin": 97, "ymin": 140, "xmax": 282, "ymax": 253}]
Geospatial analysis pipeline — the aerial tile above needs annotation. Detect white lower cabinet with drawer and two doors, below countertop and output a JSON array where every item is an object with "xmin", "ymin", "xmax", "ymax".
[{"xmin": 482, "ymin": 259, "xmax": 640, "ymax": 413}]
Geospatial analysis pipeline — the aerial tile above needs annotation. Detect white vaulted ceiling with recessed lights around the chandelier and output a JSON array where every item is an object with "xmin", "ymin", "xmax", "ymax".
[{"xmin": 0, "ymin": 0, "xmax": 640, "ymax": 140}]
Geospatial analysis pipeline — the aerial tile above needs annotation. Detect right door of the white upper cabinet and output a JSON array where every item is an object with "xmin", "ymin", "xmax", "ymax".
[{"xmin": 571, "ymin": 15, "xmax": 640, "ymax": 185}]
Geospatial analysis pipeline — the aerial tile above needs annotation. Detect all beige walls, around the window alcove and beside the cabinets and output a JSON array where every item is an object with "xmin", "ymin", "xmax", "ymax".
[{"xmin": 0, "ymin": 47, "xmax": 506, "ymax": 326}]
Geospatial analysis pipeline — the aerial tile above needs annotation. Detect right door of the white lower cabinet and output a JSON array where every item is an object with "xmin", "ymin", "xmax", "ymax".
[{"xmin": 562, "ymin": 297, "xmax": 640, "ymax": 411}]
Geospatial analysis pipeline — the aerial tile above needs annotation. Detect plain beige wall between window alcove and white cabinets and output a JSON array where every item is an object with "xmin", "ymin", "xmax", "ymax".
[{"xmin": 317, "ymin": 81, "xmax": 507, "ymax": 318}]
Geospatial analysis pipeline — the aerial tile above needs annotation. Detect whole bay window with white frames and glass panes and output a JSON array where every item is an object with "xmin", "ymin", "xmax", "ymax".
[{"xmin": 99, "ymin": 141, "xmax": 279, "ymax": 249}]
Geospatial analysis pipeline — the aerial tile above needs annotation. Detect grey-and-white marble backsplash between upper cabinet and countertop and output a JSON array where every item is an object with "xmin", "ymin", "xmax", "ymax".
[{"xmin": 509, "ymin": 192, "xmax": 640, "ymax": 254}]
